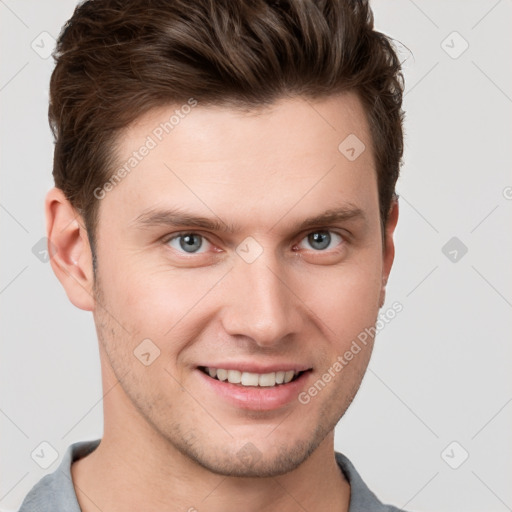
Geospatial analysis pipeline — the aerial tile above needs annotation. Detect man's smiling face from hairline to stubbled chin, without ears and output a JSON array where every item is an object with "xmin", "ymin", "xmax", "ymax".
[{"xmin": 89, "ymin": 94, "xmax": 394, "ymax": 476}]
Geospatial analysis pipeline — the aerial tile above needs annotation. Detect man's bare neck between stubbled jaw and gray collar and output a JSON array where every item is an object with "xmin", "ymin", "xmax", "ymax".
[{"xmin": 71, "ymin": 356, "xmax": 350, "ymax": 512}]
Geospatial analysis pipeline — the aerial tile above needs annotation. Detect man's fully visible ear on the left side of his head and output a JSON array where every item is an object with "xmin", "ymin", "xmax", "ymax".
[{"xmin": 45, "ymin": 188, "xmax": 95, "ymax": 311}]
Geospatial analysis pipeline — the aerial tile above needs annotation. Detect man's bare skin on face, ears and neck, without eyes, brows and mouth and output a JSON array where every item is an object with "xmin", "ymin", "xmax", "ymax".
[{"xmin": 46, "ymin": 93, "xmax": 398, "ymax": 512}]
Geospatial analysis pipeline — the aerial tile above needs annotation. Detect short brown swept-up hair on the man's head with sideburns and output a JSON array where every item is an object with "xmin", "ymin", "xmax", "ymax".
[{"xmin": 48, "ymin": 0, "xmax": 403, "ymax": 264}]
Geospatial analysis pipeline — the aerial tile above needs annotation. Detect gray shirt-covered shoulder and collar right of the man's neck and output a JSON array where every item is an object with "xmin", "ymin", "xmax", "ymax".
[{"xmin": 334, "ymin": 452, "xmax": 412, "ymax": 512}]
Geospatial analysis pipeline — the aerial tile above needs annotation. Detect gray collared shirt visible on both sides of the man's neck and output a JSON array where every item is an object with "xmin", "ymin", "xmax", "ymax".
[{"xmin": 19, "ymin": 439, "xmax": 404, "ymax": 512}]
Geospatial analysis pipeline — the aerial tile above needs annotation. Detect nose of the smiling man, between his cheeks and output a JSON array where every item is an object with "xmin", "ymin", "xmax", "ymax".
[{"xmin": 222, "ymin": 252, "xmax": 304, "ymax": 347}]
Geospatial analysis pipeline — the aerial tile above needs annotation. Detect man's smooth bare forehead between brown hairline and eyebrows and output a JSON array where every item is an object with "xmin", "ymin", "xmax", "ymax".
[{"xmin": 101, "ymin": 93, "xmax": 378, "ymax": 233}]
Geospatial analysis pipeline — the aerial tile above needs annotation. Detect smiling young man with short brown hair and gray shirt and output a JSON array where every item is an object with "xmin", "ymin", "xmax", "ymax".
[{"xmin": 20, "ymin": 0, "xmax": 403, "ymax": 512}]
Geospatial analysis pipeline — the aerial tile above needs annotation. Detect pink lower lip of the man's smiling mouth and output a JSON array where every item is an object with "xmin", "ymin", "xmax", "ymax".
[{"xmin": 196, "ymin": 370, "xmax": 311, "ymax": 411}]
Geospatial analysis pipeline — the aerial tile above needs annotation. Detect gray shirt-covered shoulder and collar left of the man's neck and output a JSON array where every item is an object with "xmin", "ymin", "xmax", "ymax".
[{"xmin": 18, "ymin": 439, "xmax": 100, "ymax": 512}]
